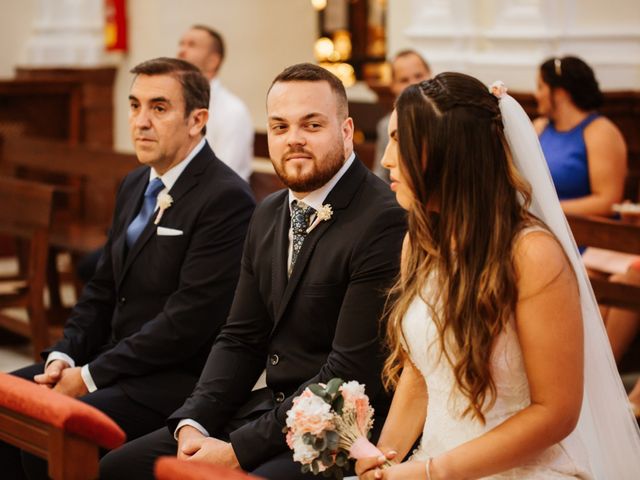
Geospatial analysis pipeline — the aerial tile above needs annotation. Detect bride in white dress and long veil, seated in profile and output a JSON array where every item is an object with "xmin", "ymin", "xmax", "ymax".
[{"xmin": 356, "ymin": 73, "xmax": 640, "ymax": 480}]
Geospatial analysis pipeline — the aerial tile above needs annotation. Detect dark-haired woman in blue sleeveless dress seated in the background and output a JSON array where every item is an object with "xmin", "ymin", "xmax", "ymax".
[{"xmin": 534, "ymin": 57, "xmax": 627, "ymax": 216}]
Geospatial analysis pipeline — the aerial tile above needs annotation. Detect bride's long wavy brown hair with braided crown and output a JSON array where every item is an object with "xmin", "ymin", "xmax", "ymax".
[{"xmin": 383, "ymin": 73, "xmax": 536, "ymax": 422}]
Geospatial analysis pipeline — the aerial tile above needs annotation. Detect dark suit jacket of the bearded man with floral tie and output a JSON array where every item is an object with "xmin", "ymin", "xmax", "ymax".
[{"xmin": 168, "ymin": 158, "xmax": 406, "ymax": 471}]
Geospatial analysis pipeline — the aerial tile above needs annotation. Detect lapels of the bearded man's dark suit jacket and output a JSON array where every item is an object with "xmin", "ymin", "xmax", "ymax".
[{"xmin": 274, "ymin": 157, "xmax": 367, "ymax": 329}]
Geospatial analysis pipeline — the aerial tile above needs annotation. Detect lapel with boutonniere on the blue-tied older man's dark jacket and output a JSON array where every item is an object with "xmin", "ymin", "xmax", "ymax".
[{"xmin": 118, "ymin": 144, "xmax": 213, "ymax": 284}]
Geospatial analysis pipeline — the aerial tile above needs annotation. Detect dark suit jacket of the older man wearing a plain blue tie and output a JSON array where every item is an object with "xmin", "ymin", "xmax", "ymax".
[{"xmin": 43, "ymin": 144, "xmax": 254, "ymax": 415}]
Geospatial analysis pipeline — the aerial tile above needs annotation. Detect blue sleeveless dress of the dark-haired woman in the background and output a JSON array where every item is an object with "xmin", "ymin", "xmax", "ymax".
[{"xmin": 540, "ymin": 113, "xmax": 600, "ymax": 200}]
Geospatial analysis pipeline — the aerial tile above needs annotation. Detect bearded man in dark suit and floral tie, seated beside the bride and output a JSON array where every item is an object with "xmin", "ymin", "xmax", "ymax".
[{"xmin": 101, "ymin": 64, "xmax": 405, "ymax": 479}]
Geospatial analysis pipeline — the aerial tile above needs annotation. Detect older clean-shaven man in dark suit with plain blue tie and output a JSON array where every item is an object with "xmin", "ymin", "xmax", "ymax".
[{"xmin": 0, "ymin": 58, "xmax": 254, "ymax": 478}]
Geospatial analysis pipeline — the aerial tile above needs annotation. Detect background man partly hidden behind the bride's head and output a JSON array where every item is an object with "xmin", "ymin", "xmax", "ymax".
[{"xmin": 373, "ymin": 50, "xmax": 431, "ymax": 181}]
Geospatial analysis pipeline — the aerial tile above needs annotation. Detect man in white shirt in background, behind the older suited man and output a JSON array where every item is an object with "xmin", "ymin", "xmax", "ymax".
[{"xmin": 178, "ymin": 25, "xmax": 254, "ymax": 182}]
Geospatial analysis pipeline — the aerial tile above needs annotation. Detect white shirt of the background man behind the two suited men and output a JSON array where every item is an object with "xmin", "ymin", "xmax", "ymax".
[{"xmin": 206, "ymin": 78, "xmax": 254, "ymax": 182}]
